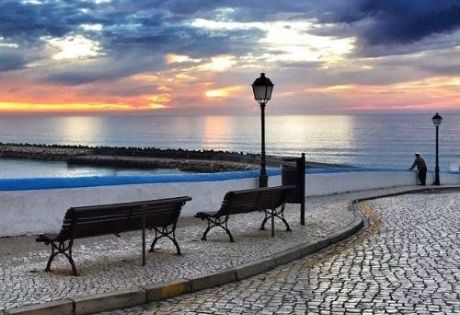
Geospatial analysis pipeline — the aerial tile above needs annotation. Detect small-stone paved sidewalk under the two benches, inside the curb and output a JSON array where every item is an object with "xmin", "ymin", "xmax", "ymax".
[{"xmin": 0, "ymin": 189, "xmax": 360, "ymax": 310}]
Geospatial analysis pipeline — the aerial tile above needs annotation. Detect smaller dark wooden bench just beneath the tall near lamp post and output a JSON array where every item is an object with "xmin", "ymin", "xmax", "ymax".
[{"xmin": 195, "ymin": 186, "xmax": 295, "ymax": 242}]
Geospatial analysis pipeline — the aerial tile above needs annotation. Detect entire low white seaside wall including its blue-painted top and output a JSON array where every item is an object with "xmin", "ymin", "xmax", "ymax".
[{"xmin": 0, "ymin": 170, "xmax": 460, "ymax": 236}]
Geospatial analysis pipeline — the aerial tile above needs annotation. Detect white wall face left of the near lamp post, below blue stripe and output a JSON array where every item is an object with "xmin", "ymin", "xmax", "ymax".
[{"xmin": 0, "ymin": 178, "xmax": 257, "ymax": 236}]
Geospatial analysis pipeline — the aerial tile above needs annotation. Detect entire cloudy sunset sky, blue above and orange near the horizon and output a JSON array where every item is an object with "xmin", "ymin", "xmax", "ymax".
[{"xmin": 0, "ymin": 0, "xmax": 460, "ymax": 115}]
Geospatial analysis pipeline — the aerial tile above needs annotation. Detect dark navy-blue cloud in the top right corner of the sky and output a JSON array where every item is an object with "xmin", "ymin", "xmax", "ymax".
[{"xmin": 332, "ymin": 0, "xmax": 460, "ymax": 45}]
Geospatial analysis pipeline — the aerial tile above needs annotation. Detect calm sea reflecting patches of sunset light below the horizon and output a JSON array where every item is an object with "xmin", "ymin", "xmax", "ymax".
[{"xmin": 0, "ymin": 113, "xmax": 460, "ymax": 178}]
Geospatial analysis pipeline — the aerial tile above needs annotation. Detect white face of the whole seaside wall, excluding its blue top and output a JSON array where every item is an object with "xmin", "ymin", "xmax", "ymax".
[{"xmin": 0, "ymin": 171, "xmax": 460, "ymax": 236}]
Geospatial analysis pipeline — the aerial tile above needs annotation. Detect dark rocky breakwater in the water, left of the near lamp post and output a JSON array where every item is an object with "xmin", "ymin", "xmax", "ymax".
[{"xmin": 0, "ymin": 144, "xmax": 258, "ymax": 173}]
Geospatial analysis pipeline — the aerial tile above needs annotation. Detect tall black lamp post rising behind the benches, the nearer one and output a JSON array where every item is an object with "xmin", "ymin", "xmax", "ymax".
[{"xmin": 252, "ymin": 73, "xmax": 273, "ymax": 187}]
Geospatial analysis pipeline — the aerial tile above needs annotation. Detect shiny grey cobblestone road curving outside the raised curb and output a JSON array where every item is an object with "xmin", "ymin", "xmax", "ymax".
[{"xmin": 100, "ymin": 192, "xmax": 460, "ymax": 315}]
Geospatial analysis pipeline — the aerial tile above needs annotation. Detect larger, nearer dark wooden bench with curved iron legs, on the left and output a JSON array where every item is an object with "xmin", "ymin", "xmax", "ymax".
[{"xmin": 36, "ymin": 196, "xmax": 192, "ymax": 275}]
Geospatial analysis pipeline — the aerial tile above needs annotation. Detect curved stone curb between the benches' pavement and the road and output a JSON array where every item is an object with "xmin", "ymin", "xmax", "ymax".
[{"xmin": 0, "ymin": 202, "xmax": 364, "ymax": 315}]
